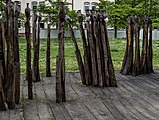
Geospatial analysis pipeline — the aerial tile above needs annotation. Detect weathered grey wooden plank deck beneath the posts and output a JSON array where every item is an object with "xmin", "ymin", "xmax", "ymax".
[{"xmin": 0, "ymin": 71, "xmax": 159, "ymax": 120}]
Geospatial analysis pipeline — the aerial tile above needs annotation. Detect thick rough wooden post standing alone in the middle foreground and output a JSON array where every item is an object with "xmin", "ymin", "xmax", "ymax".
[{"xmin": 56, "ymin": 2, "xmax": 66, "ymax": 103}]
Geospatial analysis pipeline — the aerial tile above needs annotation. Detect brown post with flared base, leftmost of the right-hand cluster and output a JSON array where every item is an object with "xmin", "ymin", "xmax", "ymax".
[{"xmin": 121, "ymin": 17, "xmax": 134, "ymax": 75}]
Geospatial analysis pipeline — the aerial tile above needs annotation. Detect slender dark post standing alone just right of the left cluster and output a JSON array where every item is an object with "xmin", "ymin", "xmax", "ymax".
[{"xmin": 25, "ymin": 3, "xmax": 33, "ymax": 99}]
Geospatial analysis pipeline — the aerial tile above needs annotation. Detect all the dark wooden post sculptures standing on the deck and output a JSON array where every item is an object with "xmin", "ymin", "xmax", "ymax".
[{"xmin": 0, "ymin": 0, "xmax": 153, "ymax": 110}]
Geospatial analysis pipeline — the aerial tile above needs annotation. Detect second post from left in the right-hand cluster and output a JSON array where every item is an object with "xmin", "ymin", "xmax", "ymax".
[{"xmin": 133, "ymin": 17, "xmax": 141, "ymax": 76}]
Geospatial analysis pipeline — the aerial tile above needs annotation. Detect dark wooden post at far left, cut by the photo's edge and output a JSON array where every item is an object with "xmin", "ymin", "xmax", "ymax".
[{"xmin": 0, "ymin": 11, "xmax": 6, "ymax": 111}]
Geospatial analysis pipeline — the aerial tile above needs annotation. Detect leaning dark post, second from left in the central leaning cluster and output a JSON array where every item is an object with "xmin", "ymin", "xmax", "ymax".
[{"xmin": 78, "ymin": 11, "xmax": 91, "ymax": 85}]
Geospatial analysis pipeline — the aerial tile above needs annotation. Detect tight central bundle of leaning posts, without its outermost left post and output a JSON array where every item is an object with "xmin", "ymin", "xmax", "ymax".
[{"xmin": 77, "ymin": 10, "xmax": 117, "ymax": 87}]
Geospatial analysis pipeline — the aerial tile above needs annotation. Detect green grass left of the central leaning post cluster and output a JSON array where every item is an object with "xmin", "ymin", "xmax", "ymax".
[{"xmin": 19, "ymin": 39, "xmax": 83, "ymax": 73}]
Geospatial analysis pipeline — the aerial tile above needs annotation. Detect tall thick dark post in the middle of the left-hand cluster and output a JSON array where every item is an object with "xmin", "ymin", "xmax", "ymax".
[{"xmin": 6, "ymin": 1, "xmax": 15, "ymax": 109}]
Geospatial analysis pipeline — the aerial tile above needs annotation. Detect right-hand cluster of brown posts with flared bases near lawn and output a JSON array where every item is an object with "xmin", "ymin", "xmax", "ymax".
[{"xmin": 121, "ymin": 16, "xmax": 153, "ymax": 76}]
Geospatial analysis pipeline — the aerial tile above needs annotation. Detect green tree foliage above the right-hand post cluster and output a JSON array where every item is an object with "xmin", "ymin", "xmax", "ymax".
[{"xmin": 98, "ymin": 0, "xmax": 159, "ymax": 28}]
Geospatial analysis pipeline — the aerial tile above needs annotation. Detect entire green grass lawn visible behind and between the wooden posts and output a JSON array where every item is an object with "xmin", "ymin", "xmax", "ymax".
[{"xmin": 19, "ymin": 39, "xmax": 159, "ymax": 73}]
